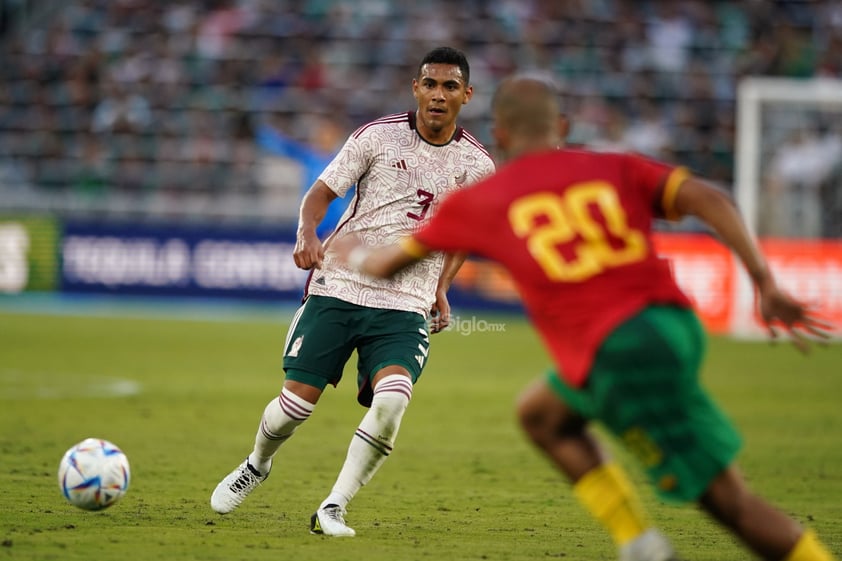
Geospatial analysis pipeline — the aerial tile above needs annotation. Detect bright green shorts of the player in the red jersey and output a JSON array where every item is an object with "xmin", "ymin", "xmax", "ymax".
[{"xmin": 547, "ymin": 306, "xmax": 741, "ymax": 502}]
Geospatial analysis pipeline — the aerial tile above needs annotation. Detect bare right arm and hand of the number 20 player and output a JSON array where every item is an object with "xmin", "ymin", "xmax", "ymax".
[{"xmin": 674, "ymin": 177, "xmax": 833, "ymax": 352}]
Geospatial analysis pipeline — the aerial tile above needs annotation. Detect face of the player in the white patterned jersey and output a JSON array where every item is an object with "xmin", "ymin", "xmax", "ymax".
[{"xmin": 412, "ymin": 63, "xmax": 473, "ymax": 144}]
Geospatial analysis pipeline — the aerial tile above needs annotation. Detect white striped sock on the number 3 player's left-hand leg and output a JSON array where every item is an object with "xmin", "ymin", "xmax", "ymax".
[{"xmin": 249, "ymin": 388, "xmax": 316, "ymax": 475}]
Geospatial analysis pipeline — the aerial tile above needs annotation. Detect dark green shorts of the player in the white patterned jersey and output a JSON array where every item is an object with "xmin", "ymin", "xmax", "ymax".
[{"xmin": 284, "ymin": 296, "xmax": 430, "ymax": 407}]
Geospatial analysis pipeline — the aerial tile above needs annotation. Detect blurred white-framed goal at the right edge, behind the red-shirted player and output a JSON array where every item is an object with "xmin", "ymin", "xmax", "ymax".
[{"xmin": 731, "ymin": 77, "xmax": 842, "ymax": 335}]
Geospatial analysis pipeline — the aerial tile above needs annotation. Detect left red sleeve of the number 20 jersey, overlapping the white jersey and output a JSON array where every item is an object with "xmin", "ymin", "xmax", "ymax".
[{"xmin": 412, "ymin": 188, "xmax": 481, "ymax": 252}]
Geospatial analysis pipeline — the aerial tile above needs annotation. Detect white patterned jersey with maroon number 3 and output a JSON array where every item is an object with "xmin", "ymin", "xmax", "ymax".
[{"xmin": 306, "ymin": 112, "xmax": 494, "ymax": 315}]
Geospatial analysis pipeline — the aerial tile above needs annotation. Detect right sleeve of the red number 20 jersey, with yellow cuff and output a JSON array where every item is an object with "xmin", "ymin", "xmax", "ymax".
[{"xmin": 626, "ymin": 154, "xmax": 690, "ymax": 220}]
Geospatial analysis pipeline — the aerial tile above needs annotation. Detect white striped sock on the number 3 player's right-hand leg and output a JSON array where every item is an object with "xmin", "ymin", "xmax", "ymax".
[{"xmin": 319, "ymin": 374, "xmax": 412, "ymax": 508}]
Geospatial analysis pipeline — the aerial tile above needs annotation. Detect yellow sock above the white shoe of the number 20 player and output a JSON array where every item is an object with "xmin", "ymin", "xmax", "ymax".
[{"xmin": 573, "ymin": 463, "xmax": 649, "ymax": 546}]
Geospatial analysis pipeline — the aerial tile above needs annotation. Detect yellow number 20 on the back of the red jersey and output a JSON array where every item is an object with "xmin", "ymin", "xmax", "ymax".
[{"xmin": 509, "ymin": 181, "xmax": 648, "ymax": 282}]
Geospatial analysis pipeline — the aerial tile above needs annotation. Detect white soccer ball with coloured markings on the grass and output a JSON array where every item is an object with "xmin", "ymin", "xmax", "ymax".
[{"xmin": 58, "ymin": 438, "xmax": 131, "ymax": 510}]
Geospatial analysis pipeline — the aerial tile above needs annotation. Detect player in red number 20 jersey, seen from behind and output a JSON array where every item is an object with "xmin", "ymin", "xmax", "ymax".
[{"xmin": 341, "ymin": 76, "xmax": 833, "ymax": 561}]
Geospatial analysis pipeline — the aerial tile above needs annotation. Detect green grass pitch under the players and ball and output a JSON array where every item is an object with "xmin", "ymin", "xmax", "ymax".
[{"xmin": 0, "ymin": 313, "xmax": 842, "ymax": 561}]
